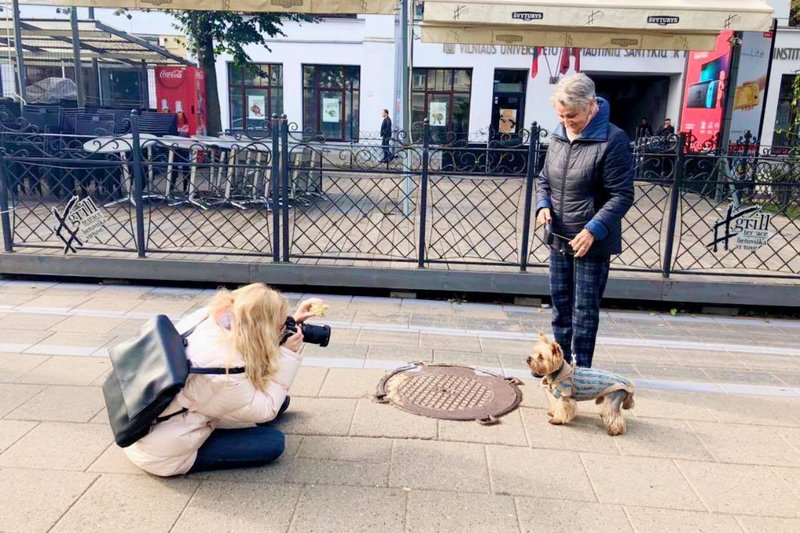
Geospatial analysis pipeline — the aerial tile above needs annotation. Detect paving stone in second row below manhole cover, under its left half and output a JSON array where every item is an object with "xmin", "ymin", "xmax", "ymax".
[{"xmin": 389, "ymin": 440, "xmax": 489, "ymax": 493}]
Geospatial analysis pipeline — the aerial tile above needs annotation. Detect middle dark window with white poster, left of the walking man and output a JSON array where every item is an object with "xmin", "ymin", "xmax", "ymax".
[{"xmin": 303, "ymin": 65, "xmax": 361, "ymax": 141}]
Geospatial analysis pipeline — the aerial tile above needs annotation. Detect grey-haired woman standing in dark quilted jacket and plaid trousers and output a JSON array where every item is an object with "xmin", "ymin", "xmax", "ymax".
[{"xmin": 536, "ymin": 74, "xmax": 634, "ymax": 367}]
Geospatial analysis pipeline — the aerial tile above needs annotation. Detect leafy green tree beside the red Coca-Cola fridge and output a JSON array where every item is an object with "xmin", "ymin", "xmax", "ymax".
[{"xmin": 118, "ymin": 9, "xmax": 317, "ymax": 134}]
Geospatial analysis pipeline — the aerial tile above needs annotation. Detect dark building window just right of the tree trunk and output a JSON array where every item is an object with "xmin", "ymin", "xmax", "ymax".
[{"xmin": 228, "ymin": 63, "xmax": 283, "ymax": 130}]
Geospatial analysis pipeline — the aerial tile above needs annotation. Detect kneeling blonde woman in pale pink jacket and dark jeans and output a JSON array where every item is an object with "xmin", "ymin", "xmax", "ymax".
[{"xmin": 124, "ymin": 283, "xmax": 322, "ymax": 476}]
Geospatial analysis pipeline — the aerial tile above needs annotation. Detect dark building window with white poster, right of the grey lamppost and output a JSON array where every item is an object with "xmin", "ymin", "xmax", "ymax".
[{"xmin": 411, "ymin": 68, "xmax": 472, "ymax": 137}]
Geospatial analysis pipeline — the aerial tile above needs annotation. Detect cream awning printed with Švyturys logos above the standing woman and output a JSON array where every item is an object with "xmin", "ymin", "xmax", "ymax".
[{"xmin": 422, "ymin": 0, "xmax": 773, "ymax": 50}]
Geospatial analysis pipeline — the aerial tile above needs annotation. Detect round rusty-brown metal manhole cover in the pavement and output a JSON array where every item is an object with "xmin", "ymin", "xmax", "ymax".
[{"xmin": 375, "ymin": 363, "xmax": 522, "ymax": 424}]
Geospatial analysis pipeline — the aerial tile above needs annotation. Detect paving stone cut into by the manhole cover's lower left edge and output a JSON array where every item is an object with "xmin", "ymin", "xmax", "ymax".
[{"xmin": 350, "ymin": 399, "xmax": 437, "ymax": 439}]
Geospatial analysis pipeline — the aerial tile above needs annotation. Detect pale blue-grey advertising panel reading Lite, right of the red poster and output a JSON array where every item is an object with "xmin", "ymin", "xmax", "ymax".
[{"xmin": 730, "ymin": 31, "xmax": 772, "ymax": 143}]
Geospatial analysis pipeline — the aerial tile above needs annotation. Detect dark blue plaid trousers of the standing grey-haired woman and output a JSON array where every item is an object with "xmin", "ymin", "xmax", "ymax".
[{"xmin": 550, "ymin": 250, "xmax": 610, "ymax": 368}]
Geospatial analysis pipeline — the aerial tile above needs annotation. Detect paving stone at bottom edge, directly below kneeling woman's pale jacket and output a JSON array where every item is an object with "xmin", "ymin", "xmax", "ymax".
[{"xmin": 52, "ymin": 474, "xmax": 199, "ymax": 533}]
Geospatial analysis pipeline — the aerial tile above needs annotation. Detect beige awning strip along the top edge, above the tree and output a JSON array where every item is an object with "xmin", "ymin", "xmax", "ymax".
[{"xmin": 21, "ymin": 0, "xmax": 397, "ymax": 15}]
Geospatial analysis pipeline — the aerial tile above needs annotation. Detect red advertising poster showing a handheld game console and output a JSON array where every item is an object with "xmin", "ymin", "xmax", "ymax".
[{"xmin": 680, "ymin": 30, "xmax": 733, "ymax": 145}]
